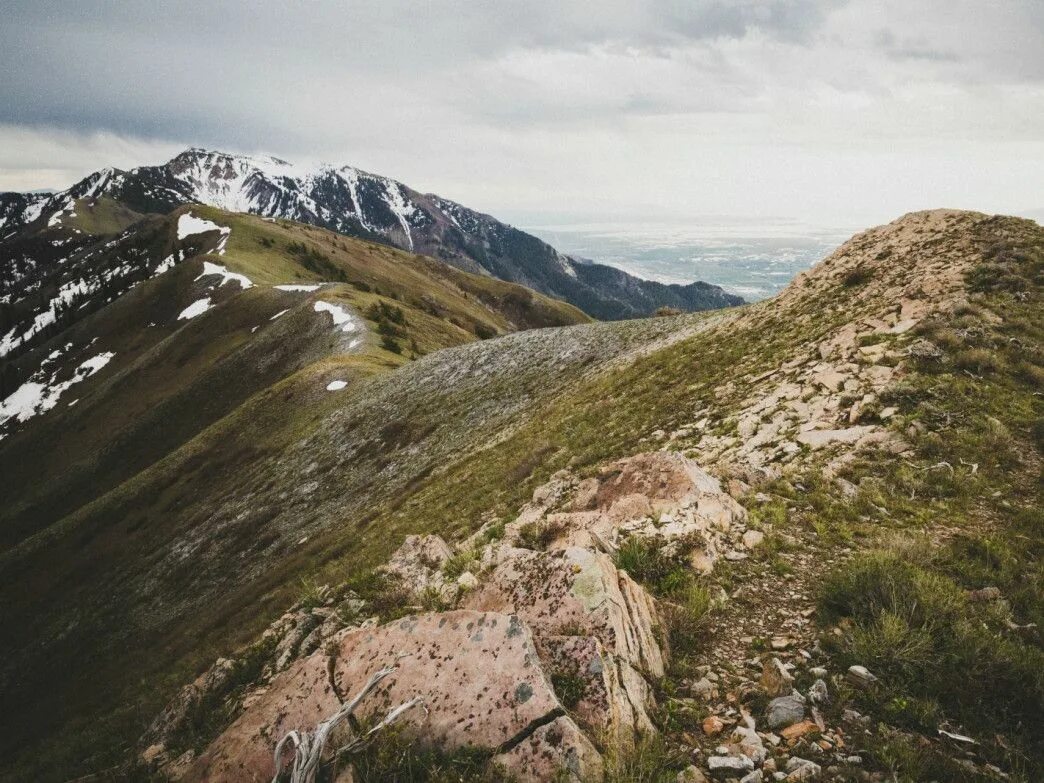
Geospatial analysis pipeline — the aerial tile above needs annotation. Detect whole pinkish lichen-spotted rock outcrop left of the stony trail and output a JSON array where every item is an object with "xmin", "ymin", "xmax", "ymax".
[{"xmin": 146, "ymin": 452, "xmax": 751, "ymax": 781}]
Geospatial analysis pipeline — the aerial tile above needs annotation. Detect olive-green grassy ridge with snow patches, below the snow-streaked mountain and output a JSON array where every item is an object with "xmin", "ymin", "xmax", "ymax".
[{"xmin": 0, "ymin": 207, "xmax": 589, "ymax": 780}]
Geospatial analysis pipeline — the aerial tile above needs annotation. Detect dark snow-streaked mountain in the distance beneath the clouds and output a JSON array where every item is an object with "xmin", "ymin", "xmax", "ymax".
[{"xmin": 0, "ymin": 149, "xmax": 742, "ymax": 318}]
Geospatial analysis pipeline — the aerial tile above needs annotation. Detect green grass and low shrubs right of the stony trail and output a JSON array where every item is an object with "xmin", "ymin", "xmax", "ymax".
[{"xmin": 820, "ymin": 219, "xmax": 1044, "ymax": 781}]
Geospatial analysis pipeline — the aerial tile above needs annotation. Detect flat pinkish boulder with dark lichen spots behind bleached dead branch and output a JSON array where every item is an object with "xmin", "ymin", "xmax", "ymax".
[{"xmin": 184, "ymin": 611, "xmax": 601, "ymax": 781}]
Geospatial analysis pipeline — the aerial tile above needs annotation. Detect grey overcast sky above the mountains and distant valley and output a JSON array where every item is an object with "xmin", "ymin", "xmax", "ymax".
[{"xmin": 0, "ymin": 0, "xmax": 1044, "ymax": 226}]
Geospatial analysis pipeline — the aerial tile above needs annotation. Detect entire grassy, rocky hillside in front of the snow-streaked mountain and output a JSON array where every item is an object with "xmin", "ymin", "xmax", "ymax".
[{"xmin": 0, "ymin": 207, "xmax": 1044, "ymax": 783}]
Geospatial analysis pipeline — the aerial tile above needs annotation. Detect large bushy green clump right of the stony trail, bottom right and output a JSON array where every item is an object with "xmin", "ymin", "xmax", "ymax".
[{"xmin": 820, "ymin": 550, "xmax": 1044, "ymax": 757}]
